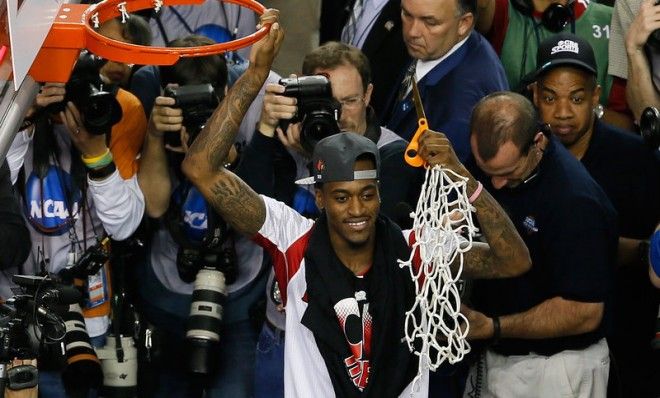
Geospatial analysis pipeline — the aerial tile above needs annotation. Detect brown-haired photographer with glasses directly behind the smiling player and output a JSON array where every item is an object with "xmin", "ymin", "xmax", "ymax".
[{"xmin": 257, "ymin": 42, "xmax": 421, "ymax": 221}]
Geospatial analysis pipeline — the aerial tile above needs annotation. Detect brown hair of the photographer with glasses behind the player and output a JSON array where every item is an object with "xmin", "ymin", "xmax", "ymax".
[{"xmin": 302, "ymin": 41, "xmax": 371, "ymax": 91}]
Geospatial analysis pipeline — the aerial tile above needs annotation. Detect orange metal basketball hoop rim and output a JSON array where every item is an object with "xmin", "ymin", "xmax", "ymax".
[{"xmin": 82, "ymin": 0, "xmax": 271, "ymax": 65}]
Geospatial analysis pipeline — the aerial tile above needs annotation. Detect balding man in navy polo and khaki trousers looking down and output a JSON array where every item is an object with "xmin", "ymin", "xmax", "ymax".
[{"xmin": 458, "ymin": 92, "xmax": 617, "ymax": 397}]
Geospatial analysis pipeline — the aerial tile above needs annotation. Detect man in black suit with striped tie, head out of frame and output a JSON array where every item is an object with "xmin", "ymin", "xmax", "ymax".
[{"xmin": 320, "ymin": 0, "xmax": 410, "ymax": 120}]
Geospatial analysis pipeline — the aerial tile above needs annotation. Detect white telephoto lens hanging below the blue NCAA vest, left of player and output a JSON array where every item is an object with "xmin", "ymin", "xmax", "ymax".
[{"xmin": 186, "ymin": 267, "xmax": 227, "ymax": 376}]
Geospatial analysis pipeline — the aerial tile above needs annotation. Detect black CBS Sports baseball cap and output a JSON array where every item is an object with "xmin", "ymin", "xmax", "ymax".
[{"xmin": 534, "ymin": 33, "xmax": 598, "ymax": 80}]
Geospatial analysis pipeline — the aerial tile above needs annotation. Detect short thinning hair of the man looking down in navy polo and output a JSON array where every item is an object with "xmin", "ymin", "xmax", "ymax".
[{"xmin": 470, "ymin": 91, "xmax": 539, "ymax": 161}]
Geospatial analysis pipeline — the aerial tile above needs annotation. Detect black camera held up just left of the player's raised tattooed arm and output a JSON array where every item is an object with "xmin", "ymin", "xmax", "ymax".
[{"xmin": 164, "ymin": 83, "xmax": 220, "ymax": 147}]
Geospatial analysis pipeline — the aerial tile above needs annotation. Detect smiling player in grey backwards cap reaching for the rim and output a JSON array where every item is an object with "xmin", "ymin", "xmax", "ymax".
[{"xmin": 183, "ymin": 12, "xmax": 529, "ymax": 397}]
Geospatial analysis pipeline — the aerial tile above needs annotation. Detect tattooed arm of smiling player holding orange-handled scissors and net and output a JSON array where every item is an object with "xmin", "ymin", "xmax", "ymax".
[{"xmin": 419, "ymin": 130, "xmax": 532, "ymax": 278}]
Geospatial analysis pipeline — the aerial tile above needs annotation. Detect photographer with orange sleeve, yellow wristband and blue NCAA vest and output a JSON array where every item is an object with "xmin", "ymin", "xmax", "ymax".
[{"xmin": 7, "ymin": 53, "xmax": 146, "ymax": 397}]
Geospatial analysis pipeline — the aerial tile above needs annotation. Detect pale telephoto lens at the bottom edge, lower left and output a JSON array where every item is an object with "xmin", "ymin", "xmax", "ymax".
[{"xmin": 96, "ymin": 335, "xmax": 137, "ymax": 398}]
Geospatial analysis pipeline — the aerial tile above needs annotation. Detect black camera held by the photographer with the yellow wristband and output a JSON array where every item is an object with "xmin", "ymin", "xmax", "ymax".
[{"xmin": 47, "ymin": 51, "xmax": 123, "ymax": 135}]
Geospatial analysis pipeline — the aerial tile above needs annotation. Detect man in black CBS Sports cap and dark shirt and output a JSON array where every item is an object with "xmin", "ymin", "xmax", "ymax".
[{"xmin": 533, "ymin": 34, "xmax": 660, "ymax": 396}]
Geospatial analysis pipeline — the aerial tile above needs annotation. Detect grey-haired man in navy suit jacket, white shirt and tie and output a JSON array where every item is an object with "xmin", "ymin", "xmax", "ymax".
[{"xmin": 383, "ymin": 0, "xmax": 509, "ymax": 161}]
